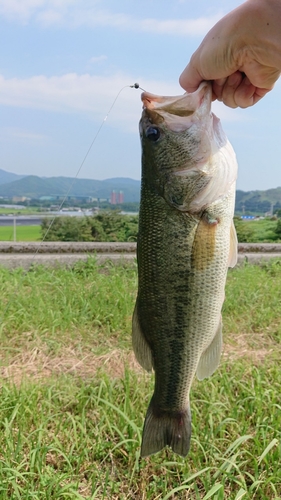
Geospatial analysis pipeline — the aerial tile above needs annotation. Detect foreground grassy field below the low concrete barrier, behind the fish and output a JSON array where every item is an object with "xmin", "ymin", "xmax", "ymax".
[{"xmin": 0, "ymin": 259, "xmax": 281, "ymax": 500}]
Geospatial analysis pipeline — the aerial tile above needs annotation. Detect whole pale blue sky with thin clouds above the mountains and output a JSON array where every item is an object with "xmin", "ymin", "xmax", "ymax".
[{"xmin": 0, "ymin": 0, "xmax": 281, "ymax": 191}]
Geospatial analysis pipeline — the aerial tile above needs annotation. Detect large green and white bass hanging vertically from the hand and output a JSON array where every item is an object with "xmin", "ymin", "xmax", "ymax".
[{"xmin": 132, "ymin": 82, "xmax": 238, "ymax": 457}]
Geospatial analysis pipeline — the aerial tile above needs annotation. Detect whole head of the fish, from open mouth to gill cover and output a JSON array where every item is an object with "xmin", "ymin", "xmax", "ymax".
[{"xmin": 140, "ymin": 82, "xmax": 236, "ymax": 210}]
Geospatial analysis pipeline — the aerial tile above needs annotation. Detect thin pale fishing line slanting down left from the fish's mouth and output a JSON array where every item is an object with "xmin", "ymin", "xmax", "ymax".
[{"xmin": 0, "ymin": 83, "xmax": 145, "ymax": 323}]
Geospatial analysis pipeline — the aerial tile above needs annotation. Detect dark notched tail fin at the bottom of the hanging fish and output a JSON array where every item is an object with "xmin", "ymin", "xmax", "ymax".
[{"xmin": 141, "ymin": 398, "xmax": 191, "ymax": 457}]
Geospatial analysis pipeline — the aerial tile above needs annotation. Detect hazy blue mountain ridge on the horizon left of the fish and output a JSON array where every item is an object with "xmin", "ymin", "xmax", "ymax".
[{"xmin": 0, "ymin": 175, "xmax": 140, "ymax": 202}]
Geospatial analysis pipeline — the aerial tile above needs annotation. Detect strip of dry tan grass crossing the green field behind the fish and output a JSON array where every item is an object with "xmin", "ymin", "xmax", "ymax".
[{"xmin": 0, "ymin": 334, "xmax": 274, "ymax": 385}]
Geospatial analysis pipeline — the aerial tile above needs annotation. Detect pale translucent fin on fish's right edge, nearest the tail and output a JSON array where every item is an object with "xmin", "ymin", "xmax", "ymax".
[{"xmin": 196, "ymin": 320, "xmax": 222, "ymax": 380}]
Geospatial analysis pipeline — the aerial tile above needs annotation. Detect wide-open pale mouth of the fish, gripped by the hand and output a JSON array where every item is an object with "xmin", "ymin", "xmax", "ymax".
[{"xmin": 141, "ymin": 82, "xmax": 212, "ymax": 132}]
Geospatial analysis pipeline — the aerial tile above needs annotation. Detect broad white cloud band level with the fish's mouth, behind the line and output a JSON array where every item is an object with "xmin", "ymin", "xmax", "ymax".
[{"xmin": 0, "ymin": 73, "xmax": 241, "ymax": 131}]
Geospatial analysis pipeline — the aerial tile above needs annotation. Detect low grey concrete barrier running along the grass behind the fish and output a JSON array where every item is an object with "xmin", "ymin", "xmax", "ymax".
[{"xmin": 0, "ymin": 241, "xmax": 281, "ymax": 269}]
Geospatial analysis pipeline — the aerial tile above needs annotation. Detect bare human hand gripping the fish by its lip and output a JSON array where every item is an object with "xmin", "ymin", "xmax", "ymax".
[{"xmin": 180, "ymin": 0, "xmax": 281, "ymax": 108}]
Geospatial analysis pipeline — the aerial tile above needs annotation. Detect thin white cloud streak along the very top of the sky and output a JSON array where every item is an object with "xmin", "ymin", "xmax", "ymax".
[{"xmin": 0, "ymin": 0, "xmax": 222, "ymax": 36}]
